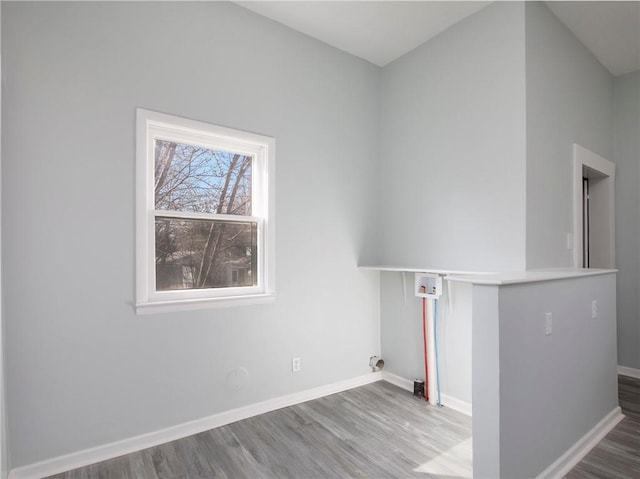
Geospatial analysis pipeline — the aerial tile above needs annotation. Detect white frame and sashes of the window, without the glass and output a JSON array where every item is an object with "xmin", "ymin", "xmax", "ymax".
[{"xmin": 136, "ymin": 108, "xmax": 275, "ymax": 314}]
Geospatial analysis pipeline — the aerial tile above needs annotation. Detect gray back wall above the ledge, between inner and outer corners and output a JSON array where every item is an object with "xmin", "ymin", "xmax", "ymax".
[{"xmin": 376, "ymin": 2, "xmax": 525, "ymax": 271}]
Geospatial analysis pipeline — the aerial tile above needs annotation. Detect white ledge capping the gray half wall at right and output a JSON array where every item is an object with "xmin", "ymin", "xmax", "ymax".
[{"xmin": 445, "ymin": 268, "xmax": 618, "ymax": 286}]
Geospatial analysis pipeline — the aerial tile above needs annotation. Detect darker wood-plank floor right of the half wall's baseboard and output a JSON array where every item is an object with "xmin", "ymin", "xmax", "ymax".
[{"xmin": 565, "ymin": 376, "xmax": 640, "ymax": 479}]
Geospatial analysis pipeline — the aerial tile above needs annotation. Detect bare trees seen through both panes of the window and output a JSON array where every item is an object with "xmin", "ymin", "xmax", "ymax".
[{"xmin": 154, "ymin": 139, "xmax": 257, "ymax": 291}]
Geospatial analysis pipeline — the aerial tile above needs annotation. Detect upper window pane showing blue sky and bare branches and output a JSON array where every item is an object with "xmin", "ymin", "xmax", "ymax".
[{"xmin": 154, "ymin": 140, "xmax": 252, "ymax": 216}]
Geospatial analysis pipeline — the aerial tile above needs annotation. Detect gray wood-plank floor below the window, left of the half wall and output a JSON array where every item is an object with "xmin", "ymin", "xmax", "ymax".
[{"xmin": 50, "ymin": 381, "xmax": 472, "ymax": 479}]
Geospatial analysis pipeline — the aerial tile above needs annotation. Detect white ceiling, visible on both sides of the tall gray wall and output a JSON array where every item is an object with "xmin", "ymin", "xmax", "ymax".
[{"xmin": 236, "ymin": 1, "xmax": 640, "ymax": 76}]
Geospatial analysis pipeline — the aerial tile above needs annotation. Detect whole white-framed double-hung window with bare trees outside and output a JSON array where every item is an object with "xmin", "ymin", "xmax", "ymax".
[{"xmin": 136, "ymin": 109, "xmax": 275, "ymax": 313}]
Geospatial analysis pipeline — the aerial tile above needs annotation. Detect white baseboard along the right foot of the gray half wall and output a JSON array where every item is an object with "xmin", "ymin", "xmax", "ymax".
[{"xmin": 536, "ymin": 407, "xmax": 624, "ymax": 479}]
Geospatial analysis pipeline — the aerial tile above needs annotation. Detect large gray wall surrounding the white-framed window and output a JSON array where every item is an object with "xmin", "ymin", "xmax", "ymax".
[{"xmin": 2, "ymin": 2, "xmax": 379, "ymax": 467}]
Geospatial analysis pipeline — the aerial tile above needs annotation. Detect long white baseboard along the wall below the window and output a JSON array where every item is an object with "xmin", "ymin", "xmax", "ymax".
[{"xmin": 9, "ymin": 372, "xmax": 382, "ymax": 479}]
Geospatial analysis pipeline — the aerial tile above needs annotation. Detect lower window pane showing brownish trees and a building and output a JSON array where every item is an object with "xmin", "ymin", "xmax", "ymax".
[{"xmin": 156, "ymin": 217, "xmax": 257, "ymax": 291}]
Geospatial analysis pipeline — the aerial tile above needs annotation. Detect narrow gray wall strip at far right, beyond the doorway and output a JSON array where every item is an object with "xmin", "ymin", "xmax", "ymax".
[{"xmin": 613, "ymin": 72, "xmax": 640, "ymax": 369}]
